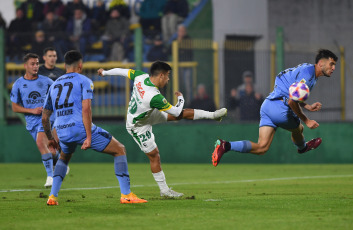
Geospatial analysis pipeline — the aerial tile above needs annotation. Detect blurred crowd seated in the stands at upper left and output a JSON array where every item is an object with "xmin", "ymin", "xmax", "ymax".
[{"xmin": 0, "ymin": 0, "xmax": 192, "ymax": 62}]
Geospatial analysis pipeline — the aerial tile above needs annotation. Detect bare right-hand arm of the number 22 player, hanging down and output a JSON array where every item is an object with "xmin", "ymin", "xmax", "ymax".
[{"xmin": 81, "ymin": 99, "xmax": 92, "ymax": 150}]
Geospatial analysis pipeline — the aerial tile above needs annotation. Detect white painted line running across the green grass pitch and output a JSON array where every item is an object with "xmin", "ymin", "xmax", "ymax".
[{"xmin": 0, "ymin": 175, "xmax": 353, "ymax": 193}]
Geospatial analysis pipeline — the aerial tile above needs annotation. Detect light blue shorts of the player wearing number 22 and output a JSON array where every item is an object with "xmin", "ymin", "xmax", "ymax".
[{"xmin": 60, "ymin": 126, "xmax": 112, "ymax": 154}]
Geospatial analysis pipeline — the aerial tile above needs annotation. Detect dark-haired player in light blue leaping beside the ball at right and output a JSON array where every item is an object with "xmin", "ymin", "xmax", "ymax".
[{"xmin": 212, "ymin": 49, "xmax": 338, "ymax": 166}]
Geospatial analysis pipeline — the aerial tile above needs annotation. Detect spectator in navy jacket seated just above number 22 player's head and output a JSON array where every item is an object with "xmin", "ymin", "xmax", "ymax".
[{"xmin": 66, "ymin": 9, "xmax": 94, "ymax": 56}]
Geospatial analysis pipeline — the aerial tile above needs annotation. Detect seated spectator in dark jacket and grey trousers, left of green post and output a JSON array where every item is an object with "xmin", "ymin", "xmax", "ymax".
[{"xmin": 102, "ymin": 9, "xmax": 129, "ymax": 61}]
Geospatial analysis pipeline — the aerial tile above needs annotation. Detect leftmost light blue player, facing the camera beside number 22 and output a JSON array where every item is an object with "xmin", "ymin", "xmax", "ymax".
[{"xmin": 10, "ymin": 53, "xmax": 57, "ymax": 187}]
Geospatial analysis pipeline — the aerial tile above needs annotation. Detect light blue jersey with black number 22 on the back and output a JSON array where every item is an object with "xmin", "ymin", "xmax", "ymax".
[{"xmin": 44, "ymin": 73, "xmax": 94, "ymax": 142}]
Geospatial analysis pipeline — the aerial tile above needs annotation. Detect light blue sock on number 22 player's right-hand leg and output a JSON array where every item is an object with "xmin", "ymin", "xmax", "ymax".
[{"xmin": 114, "ymin": 155, "xmax": 131, "ymax": 195}]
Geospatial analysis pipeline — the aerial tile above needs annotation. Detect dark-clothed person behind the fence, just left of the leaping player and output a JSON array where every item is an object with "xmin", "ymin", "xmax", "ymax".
[{"xmin": 239, "ymin": 83, "xmax": 263, "ymax": 121}]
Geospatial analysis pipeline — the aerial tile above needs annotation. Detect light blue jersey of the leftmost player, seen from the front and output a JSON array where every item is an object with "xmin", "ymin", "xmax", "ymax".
[{"xmin": 10, "ymin": 75, "xmax": 53, "ymax": 130}]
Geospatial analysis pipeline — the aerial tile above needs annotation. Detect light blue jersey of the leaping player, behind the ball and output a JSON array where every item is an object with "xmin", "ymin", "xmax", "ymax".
[{"xmin": 267, "ymin": 63, "xmax": 317, "ymax": 101}]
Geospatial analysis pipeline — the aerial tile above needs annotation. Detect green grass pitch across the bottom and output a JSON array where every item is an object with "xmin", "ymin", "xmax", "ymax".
[{"xmin": 0, "ymin": 163, "xmax": 353, "ymax": 230}]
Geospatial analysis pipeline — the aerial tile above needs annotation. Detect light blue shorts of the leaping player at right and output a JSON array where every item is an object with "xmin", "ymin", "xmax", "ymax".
[{"xmin": 260, "ymin": 99, "xmax": 300, "ymax": 129}]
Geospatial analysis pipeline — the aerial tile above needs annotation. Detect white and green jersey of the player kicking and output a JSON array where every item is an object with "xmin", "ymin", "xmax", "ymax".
[{"xmin": 126, "ymin": 69, "xmax": 172, "ymax": 127}]
